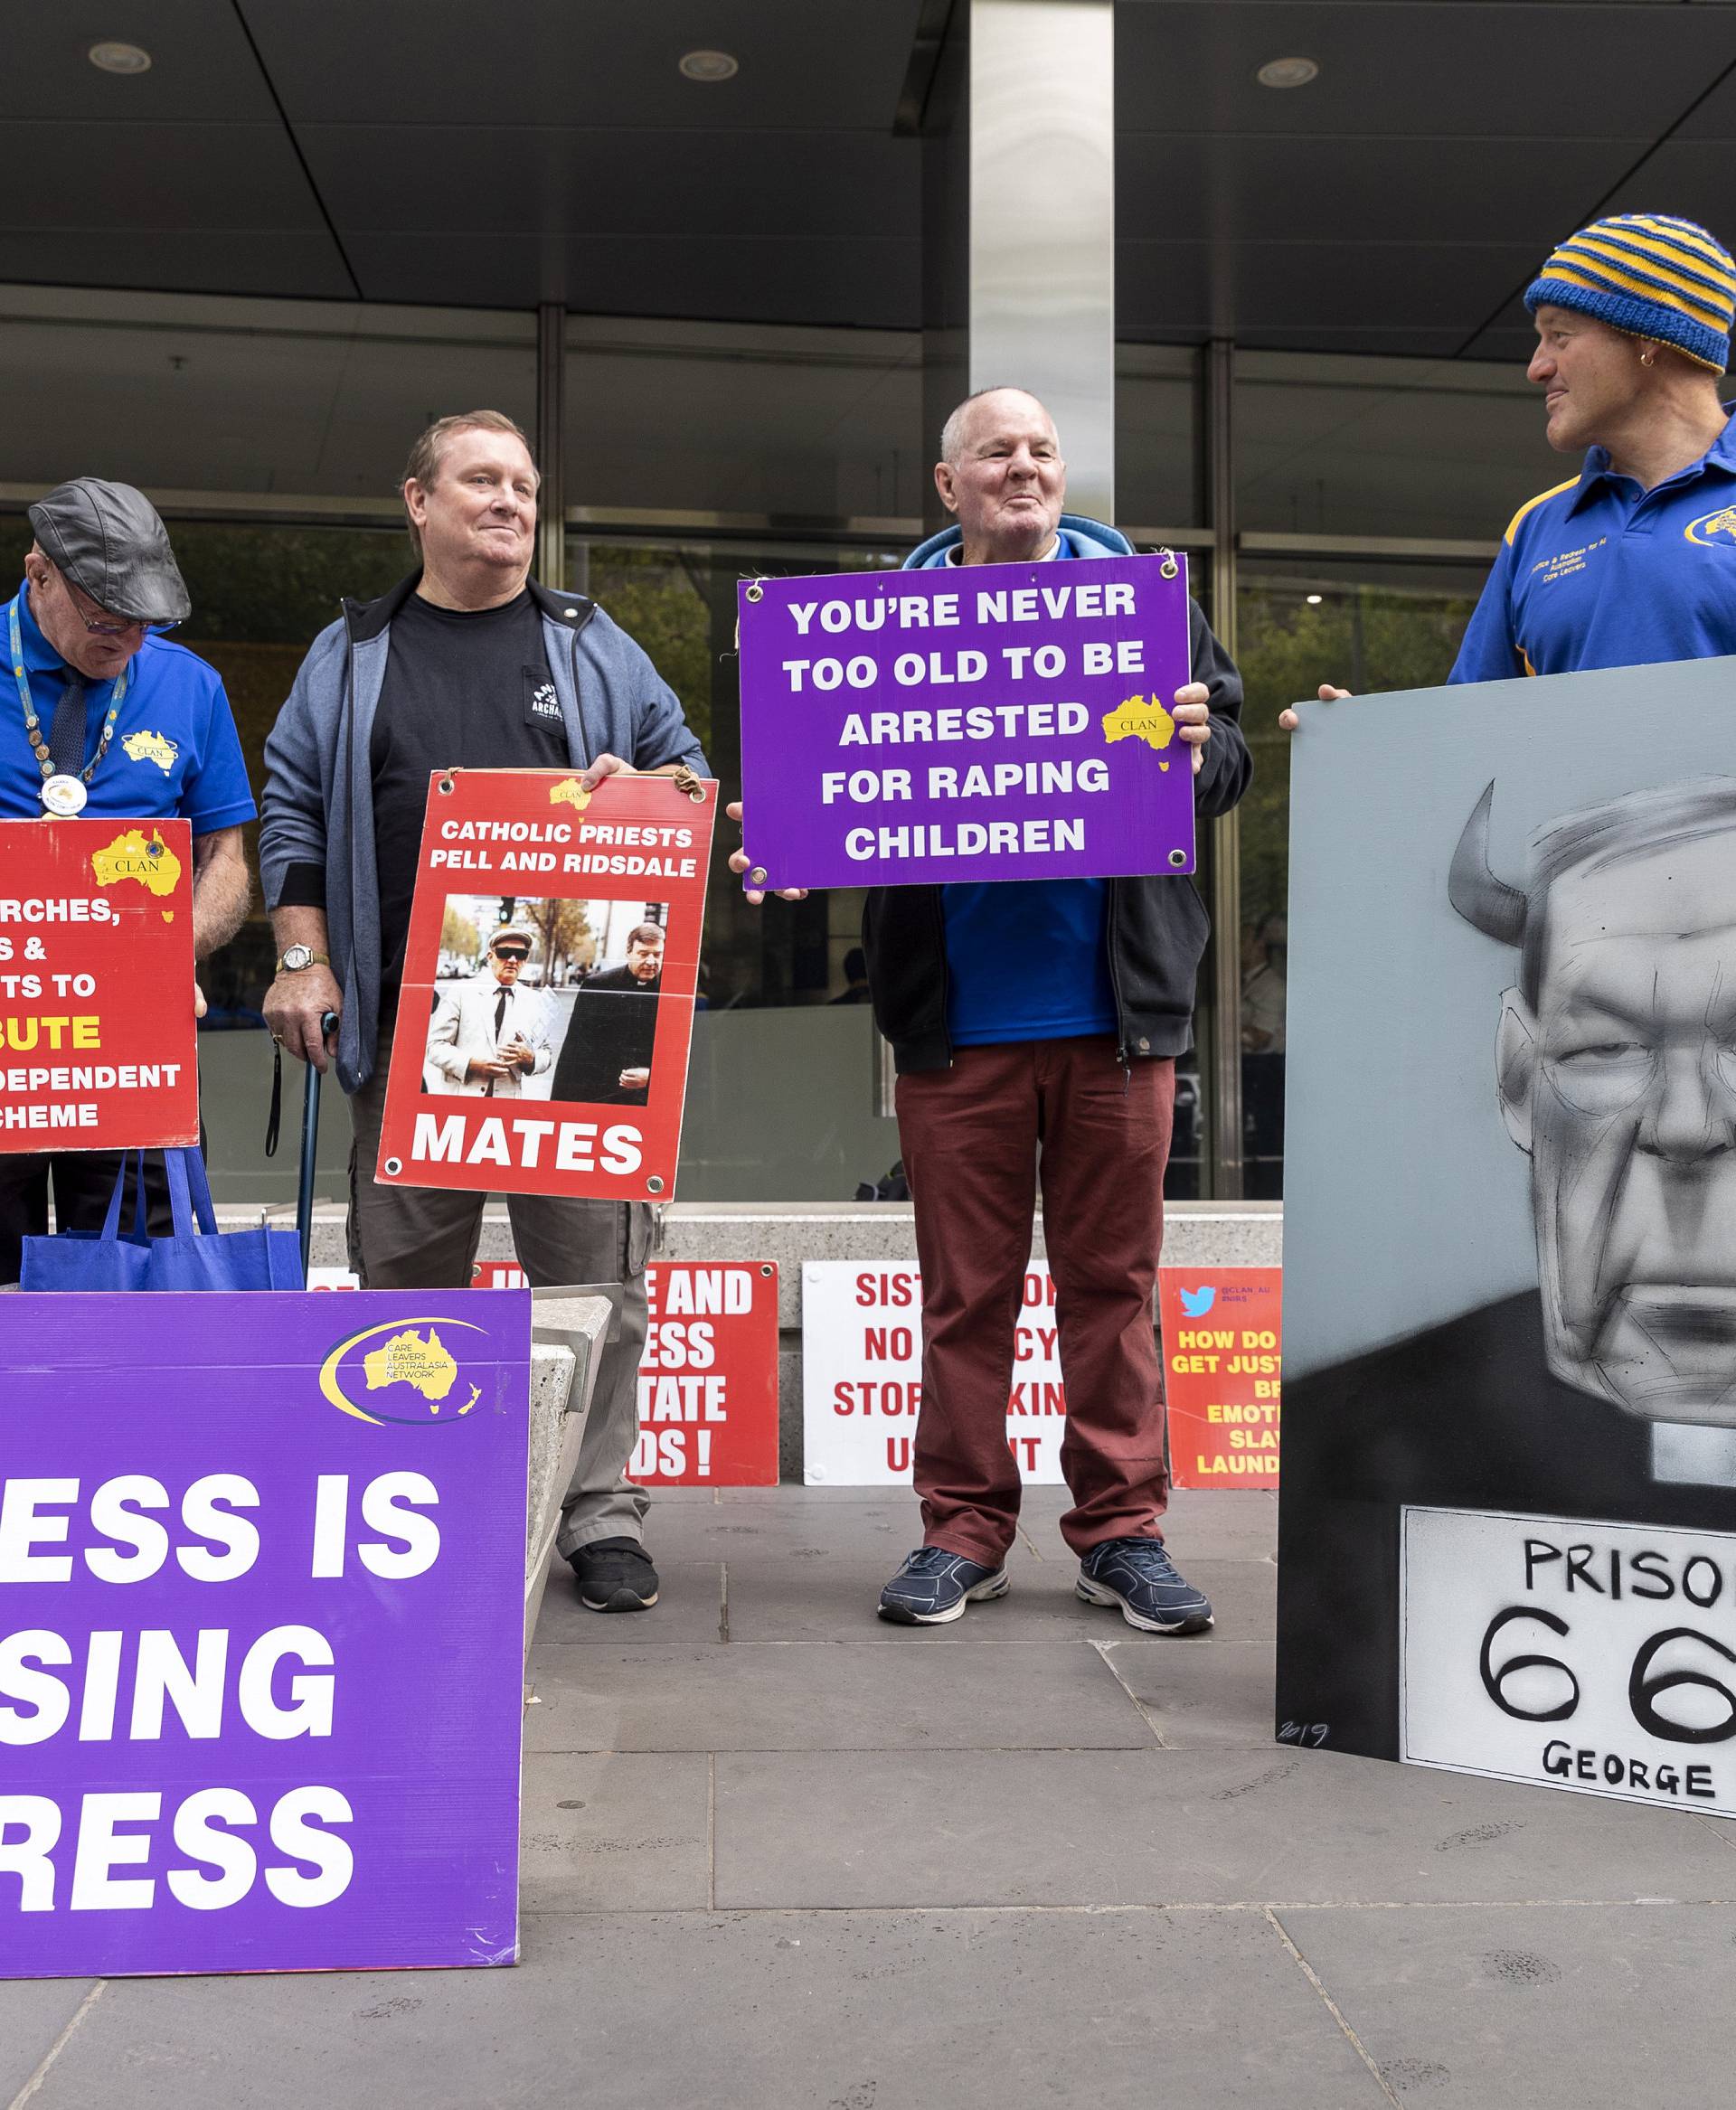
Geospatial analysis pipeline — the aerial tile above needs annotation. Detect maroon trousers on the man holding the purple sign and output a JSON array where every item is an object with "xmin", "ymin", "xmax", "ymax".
[{"xmin": 899, "ymin": 1034, "xmax": 1175, "ymax": 1568}]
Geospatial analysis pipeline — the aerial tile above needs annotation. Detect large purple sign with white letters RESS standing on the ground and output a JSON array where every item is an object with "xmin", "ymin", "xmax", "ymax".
[{"xmin": 0, "ymin": 1289, "xmax": 530, "ymax": 1977}]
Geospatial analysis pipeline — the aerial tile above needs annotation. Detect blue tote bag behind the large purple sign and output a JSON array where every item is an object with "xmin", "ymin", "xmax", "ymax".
[{"xmin": 19, "ymin": 1150, "xmax": 304, "ymax": 1289}]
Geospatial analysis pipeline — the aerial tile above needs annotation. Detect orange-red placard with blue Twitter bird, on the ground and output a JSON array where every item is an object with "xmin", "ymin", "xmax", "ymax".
[{"xmin": 1158, "ymin": 1268, "xmax": 1285, "ymax": 1487}]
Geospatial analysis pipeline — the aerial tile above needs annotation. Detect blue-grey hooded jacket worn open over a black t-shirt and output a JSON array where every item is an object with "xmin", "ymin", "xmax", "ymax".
[{"xmin": 259, "ymin": 572, "xmax": 711, "ymax": 1091}]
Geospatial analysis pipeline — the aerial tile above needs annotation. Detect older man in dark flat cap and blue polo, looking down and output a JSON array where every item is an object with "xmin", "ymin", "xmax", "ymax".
[{"xmin": 0, "ymin": 476, "xmax": 253, "ymax": 1283}]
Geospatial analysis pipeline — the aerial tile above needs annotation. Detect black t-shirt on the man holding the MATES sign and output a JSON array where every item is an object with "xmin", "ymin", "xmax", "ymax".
[{"xmin": 369, "ymin": 589, "xmax": 570, "ymax": 998}]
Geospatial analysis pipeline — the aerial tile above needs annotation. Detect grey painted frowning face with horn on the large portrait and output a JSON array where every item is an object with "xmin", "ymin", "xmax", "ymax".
[{"xmin": 1447, "ymin": 778, "xmax": 1736, "ymax": 1427}]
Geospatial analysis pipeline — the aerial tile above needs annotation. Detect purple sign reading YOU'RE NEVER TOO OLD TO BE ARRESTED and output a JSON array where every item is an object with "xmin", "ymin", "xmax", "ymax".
[{"xmin": 739, "ymin": 553, "xmax": 1194, "ymax": 889}]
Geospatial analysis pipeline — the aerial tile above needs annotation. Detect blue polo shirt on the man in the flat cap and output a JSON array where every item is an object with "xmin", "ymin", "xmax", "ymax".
[{"xmin": 0, "ymin": 587, "xmax": 258, "ymax": 835}]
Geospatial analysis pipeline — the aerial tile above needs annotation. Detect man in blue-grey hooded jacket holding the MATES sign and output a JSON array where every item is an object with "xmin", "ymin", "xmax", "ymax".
[{"xmin": 259, "ymin": 410, "xmax": 707, "ymax": 1612}]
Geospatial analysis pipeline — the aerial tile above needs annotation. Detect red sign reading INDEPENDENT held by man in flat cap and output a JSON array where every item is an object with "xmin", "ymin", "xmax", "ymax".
[{"xmin": 0, "ymin": 819, "xmax": 198, "ymax": 1150}]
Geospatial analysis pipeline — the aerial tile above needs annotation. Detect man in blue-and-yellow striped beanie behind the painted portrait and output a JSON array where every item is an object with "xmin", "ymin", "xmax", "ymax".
[{"xmin": 1449, "ymin": 213, "xmax": 1736, "ymax": 682}]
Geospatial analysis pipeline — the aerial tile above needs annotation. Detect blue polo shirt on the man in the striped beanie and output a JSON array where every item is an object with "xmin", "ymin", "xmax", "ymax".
[{"xmin": 1447, "ymin": 407, "xmax": 1736, "ymax": 682}]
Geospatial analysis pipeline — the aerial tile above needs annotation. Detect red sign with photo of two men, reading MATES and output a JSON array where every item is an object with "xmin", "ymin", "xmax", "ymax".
[{"xmin": 375, "ymin": 770, "xmax": 717, "ymax": 1201}]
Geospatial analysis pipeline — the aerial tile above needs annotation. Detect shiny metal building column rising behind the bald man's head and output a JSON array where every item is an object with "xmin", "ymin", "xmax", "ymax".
[{"xmin": 921, "ymin": 0, "xmax": 1116, "ymax": 521}]
